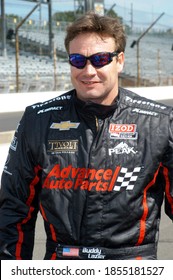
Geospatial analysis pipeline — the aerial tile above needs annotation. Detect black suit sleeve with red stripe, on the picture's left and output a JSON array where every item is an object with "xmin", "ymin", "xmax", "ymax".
[{"xmin": 0, "ymin": 112, "xmax": 40, "ymax": 260}]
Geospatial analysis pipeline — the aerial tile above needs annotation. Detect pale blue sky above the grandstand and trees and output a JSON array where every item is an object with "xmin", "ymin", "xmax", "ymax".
[{"xmin": 1, "ymin": 0, "xmax": 173, "ymax": 28}]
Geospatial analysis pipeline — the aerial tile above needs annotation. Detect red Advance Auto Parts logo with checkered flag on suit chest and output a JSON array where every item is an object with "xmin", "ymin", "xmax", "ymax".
[{"xmin": 43, "ymin": 164, "xmax": 141, "ymax": 192}]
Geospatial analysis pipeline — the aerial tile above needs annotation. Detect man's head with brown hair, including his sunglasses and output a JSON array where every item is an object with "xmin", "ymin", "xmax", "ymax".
[{"xmin": 65, "ymin": 12, "xmax": 126, "ymax": 105}]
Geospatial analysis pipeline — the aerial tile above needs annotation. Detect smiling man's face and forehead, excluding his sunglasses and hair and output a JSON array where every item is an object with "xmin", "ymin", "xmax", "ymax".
[{"xmin": 69, "ymin": 33, "xmax": 124, "ymax": 105}]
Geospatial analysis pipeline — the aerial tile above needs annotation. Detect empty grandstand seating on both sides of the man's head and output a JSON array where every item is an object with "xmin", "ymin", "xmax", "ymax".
[{"xmin": 0, "ymin": 15, "xmax": 173, "ymax": 93}]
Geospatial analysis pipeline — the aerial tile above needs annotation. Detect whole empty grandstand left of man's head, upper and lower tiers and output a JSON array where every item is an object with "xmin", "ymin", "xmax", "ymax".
[{"xmin": 0, "ymin": 19, "xmax": 71, "ymax": 93}]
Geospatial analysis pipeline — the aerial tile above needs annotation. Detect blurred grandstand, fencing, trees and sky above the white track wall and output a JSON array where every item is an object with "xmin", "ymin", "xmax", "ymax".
[{"xmin": 0, "ymin": 0, "xmax": 173, "ymax": 93}]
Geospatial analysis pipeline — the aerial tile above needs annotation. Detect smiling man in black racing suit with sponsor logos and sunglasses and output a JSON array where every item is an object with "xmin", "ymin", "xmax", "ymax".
[{"xmin": 0, "ymin": 13, "xmax": 173, "ymax": 260}]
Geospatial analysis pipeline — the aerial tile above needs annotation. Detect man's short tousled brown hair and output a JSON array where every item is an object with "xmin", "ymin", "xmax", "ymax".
[{"xmin": 64, "ymin": 12, "xmax": 126, "ymax": 52}]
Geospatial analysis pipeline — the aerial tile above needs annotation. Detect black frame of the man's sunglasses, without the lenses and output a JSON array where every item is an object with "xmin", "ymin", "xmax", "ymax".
[{"xmin": 69, "ymin": 51, "xmax": 119, "ymax": 69}]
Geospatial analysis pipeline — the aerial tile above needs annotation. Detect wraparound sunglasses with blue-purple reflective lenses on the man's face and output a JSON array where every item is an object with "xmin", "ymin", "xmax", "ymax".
[{"xmin": 69, "ymin": 52, "xmax": 118, "ymax": 69}]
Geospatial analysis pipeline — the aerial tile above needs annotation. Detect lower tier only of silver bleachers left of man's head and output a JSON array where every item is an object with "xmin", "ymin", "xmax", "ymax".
[{"xmin": 0, "ymin": 43, "xmax": 71, "ymax": 93}]
